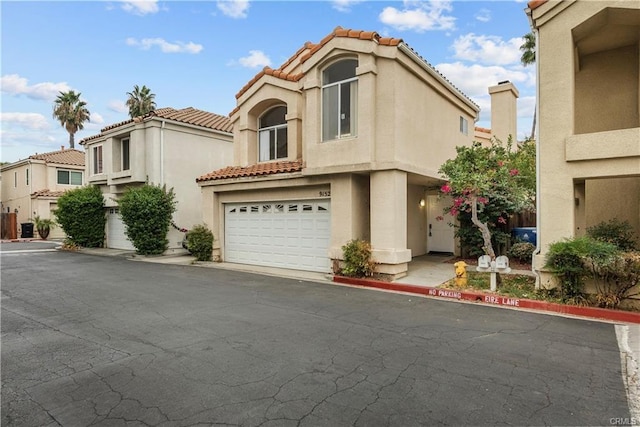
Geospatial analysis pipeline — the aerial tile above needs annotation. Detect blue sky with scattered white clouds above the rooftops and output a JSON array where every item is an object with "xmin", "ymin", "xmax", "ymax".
[{"xmin": 0, "ymin": 0, "xmax": 535, "ymax": 162}]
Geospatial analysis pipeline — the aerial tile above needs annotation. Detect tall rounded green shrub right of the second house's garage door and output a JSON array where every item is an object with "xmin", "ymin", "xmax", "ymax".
[{"xmin": 118, "ymin": 184, "xmax": 176, "ymax": 255}]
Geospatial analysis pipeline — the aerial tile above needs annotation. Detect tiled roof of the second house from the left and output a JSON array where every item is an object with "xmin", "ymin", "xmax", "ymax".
[{"xmin": 80, "ymin": 107, "xmax": 233, "ymax": 144}]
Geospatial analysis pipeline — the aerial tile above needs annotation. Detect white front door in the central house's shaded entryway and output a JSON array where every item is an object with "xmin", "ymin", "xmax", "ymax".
[{"xmin": 427, "ymin": 196, "xmax": 455, "ymax": 253}]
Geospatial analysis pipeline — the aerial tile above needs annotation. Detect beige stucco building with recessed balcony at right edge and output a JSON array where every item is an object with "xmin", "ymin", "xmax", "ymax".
[{"xmin": 527, "ymin": 0, "xmax": 640, "ymax": 284}]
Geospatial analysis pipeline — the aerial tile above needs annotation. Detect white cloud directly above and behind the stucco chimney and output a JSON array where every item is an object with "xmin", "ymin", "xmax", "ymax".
[{"xmin": 436, "ymin": 62, "xmax": 530, "ymax": 97}]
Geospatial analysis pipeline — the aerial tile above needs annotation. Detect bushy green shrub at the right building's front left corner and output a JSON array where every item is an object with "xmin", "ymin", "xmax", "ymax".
[{"xmin": 545, "ymin": 236, "xmax": 618, "ymax": 302}]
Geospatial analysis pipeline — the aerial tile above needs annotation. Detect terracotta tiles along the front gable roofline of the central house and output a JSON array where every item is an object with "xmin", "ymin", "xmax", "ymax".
[{"xmin": 235, "ymin": 27, "xmax": 402, "ymax": 101}]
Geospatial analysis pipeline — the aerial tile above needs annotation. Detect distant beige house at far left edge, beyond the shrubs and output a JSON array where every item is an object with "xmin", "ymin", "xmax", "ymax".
[{"xmin": 0, "ymin": 147, "xmax": 85, "ymax": 238}]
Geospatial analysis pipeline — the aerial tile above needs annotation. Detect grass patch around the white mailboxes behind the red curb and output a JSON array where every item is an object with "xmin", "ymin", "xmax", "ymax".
[{"xmin": 440, "ymin": 271, "xmax": 562, "ymax": 303}]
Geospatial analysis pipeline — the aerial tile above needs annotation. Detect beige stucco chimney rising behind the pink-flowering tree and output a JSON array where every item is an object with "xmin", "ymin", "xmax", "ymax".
[{"xmin": 489, "ymin": 80, "xmax": 520, "ymax": 145}]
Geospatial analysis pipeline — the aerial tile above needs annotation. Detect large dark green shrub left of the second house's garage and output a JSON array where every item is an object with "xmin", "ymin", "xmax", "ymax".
[{"xmin": 53, "ymin": 185, "xmax": 107, "ymax": 248}]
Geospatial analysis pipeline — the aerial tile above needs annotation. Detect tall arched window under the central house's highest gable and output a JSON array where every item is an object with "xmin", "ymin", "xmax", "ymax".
[{"xmin": 322, "ymin": 59, "xmax": 358, "ymax": 141}]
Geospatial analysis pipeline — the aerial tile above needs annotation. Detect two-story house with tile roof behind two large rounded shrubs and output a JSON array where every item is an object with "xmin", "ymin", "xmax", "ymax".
[{"xmin": 80, "ymin": 108, "xmax": 233, "ymax": 250}]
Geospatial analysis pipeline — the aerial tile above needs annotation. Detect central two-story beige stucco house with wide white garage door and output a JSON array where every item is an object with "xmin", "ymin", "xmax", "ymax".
[{"xmin": 197, "ymin": 27, "xmax": 479, "ymax": 277}]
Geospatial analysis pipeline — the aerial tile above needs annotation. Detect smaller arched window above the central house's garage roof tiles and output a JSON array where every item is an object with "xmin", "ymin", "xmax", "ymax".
[{"xmin": 258, "ymin": 106, "xmax": 287, "ymax": 162}]
